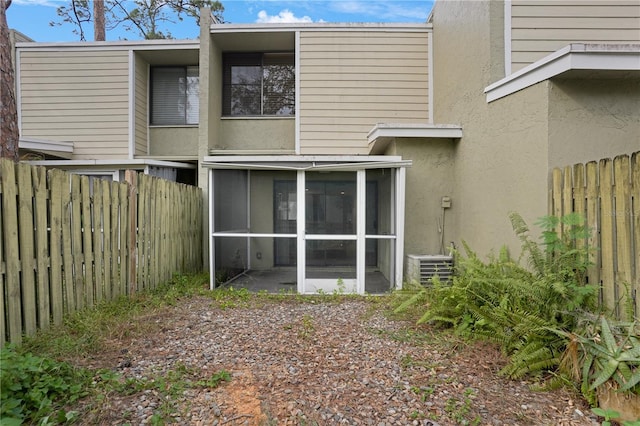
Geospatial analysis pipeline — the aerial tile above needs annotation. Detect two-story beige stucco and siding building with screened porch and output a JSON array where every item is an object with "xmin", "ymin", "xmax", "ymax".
[{"xmin": 10, "ymin": 0, "xmax": 640, "ymax": 293}]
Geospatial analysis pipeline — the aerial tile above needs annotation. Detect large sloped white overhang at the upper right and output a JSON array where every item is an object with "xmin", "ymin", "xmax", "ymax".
[{"xmin": 484, "ymin": 43, "xmax": 640, "ymax": 102}]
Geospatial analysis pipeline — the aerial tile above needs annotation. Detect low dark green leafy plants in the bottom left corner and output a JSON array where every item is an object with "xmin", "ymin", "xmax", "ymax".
[{"xmin": 0, "ymin": 346, "xmax": 91, "ymax": 426}]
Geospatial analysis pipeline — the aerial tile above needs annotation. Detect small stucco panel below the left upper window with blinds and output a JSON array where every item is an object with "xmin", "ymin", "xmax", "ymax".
[{"xmin": 149, "ymin": 126, "xmax": 198, "ymax": 157}]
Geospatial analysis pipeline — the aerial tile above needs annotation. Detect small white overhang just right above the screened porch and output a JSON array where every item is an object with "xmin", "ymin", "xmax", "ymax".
[{"xmin": 367, "ymin": 123, "xmax": 462, "ymax": 154}]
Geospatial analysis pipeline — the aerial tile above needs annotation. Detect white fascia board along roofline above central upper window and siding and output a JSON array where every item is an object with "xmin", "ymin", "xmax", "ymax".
[{"xmin": 209, "ymin": 23, "xmax": 433, "ymax": 34}]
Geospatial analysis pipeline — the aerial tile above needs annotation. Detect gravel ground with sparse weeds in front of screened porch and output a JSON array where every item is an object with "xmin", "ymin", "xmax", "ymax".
[{"xmin": 75, "ymin": 298, "xmax": 598, "ymax": 426}]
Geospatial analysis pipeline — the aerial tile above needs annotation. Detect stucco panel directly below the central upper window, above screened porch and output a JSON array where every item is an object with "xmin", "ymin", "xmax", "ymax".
[{"xmin": 212, "ymin": 118, "xmax": 295, "ymax": 152}]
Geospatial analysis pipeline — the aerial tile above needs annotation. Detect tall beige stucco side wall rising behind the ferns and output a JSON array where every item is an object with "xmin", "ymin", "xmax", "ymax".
[{"xmin": 432, "ymin": 0, "xmax": 548, "ymax": 255}]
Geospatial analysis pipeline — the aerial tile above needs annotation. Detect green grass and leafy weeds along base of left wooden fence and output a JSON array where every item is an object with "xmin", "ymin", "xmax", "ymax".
[{"xmin": 0, "ymin": 274, "xmax": 224, "ymax": 426}]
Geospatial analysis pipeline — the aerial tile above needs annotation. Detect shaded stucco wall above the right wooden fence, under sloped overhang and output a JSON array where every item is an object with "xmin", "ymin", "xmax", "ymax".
[{"xmin": 549, "ymin": 78, "xmax": 640, "ymax": 168}]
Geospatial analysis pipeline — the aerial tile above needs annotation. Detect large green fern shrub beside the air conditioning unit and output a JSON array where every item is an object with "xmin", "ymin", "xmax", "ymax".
[{"xmin": 396, "ymin": 213, "xmax": 596, "ymax": 378}]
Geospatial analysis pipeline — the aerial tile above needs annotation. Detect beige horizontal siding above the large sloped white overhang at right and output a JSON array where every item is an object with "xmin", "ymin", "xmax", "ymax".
[{"xmin": 511, "ymin": 0, "xmax": 640, "ymax": 72}]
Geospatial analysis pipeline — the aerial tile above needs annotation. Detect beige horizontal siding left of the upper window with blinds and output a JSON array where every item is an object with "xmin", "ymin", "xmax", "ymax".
[{"xmin": 19, "ymin": 48, "xmax": 129, "ymax": 160}]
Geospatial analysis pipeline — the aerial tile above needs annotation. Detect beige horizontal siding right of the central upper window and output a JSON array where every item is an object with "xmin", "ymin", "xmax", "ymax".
[{"xmin": 299, "ymin": 30, "xmax": 429, "ymax": 154}]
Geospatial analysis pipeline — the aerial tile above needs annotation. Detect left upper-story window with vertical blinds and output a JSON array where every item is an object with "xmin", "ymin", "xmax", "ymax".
[{"xmin": 150, "ymin": 67, "xmax": 200, "ymax": 126}]
